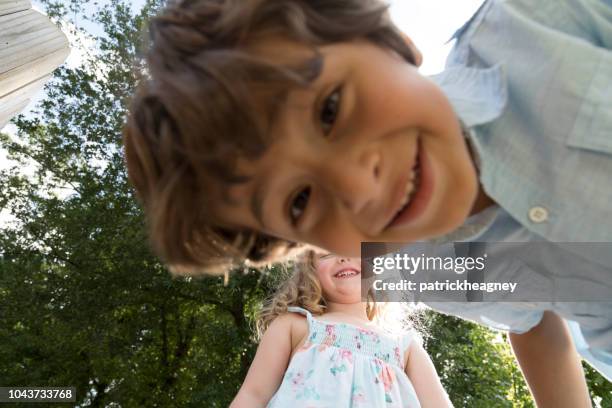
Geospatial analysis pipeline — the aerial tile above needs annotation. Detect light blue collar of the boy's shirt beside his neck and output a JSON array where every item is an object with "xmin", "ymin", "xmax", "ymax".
[{"xmin": 429, "ymin": 64, "xmax": 508, "ymax": 128}]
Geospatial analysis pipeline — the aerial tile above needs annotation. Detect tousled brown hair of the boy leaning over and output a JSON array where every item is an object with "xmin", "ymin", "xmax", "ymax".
[{"xmin": 124, "ymin": 0, "xmax": 415, "ymax": 274}]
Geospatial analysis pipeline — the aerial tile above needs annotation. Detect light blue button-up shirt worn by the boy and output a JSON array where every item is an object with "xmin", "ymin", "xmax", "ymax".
[{"xmin": 432, "ymin": 0, "xmax": 612, "ymax": 379}]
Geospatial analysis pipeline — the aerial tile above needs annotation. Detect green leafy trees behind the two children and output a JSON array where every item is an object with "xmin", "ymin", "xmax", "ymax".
[{"xmin": 0, "ymin": 0, "xmax": 611, "ymax": 407}]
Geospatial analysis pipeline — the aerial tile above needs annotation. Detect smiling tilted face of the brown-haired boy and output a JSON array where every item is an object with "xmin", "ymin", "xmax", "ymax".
[{"xmin": 213, "ymin": 36, "xmax": 478, "ymax": 256}]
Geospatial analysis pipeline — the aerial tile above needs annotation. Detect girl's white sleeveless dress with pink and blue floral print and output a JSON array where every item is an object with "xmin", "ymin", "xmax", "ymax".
[{"xmin": 267, "ymin": 307, "xmax": 421, "ymax": 408}]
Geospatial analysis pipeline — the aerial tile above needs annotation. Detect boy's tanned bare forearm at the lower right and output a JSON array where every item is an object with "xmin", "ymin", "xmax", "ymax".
[{"xmin": 510, "ymin": 312, "xmax": 592, "ymax": 408}]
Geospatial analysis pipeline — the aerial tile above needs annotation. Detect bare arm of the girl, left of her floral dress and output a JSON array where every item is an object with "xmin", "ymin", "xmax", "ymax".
[{"xmin": 230, "ymin": 313, "xmax": 296, "ymax": 408}]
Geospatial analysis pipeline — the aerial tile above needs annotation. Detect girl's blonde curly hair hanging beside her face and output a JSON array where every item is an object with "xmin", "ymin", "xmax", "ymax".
[{"xmin": 256, "ymin": 250, "xmax": 380, "ymax": 339}]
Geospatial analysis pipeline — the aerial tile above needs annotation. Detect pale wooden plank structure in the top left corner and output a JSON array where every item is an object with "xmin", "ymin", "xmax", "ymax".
[{"xmin": 0, "ymin": 0, "xmax": 70, "ymax": 130}]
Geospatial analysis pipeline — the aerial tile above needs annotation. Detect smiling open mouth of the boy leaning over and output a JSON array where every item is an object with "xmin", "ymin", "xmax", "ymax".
[{"xmin": 385, "ymin": 137, "xmax": 433, "ymax": 229}]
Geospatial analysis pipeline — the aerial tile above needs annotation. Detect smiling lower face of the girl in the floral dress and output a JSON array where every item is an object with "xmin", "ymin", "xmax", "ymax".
[{"xmin": 315, "ymin": 254, "xmax": 361, "ymax": 304}]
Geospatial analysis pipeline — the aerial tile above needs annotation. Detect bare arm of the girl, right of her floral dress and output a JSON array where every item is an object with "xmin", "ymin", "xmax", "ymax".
[{"xmin": 406, "ymin": 341, "xmax": 453, "ymax": 408}]
